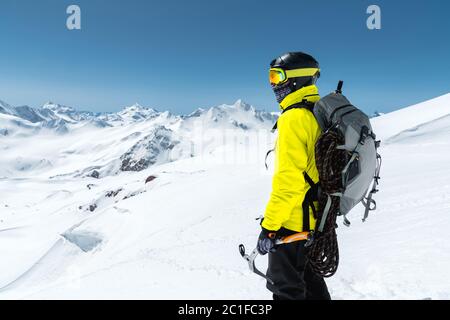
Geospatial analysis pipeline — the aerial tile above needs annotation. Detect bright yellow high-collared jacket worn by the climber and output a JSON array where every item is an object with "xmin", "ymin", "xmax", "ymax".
[{"xmin": 262, "ymin": 85, "xmax": 321, "ymax": 232}]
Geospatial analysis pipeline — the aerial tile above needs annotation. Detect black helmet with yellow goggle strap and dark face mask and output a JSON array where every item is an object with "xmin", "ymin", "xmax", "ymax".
[{"xmin": 270, "ymin": 52, "xmax": 320, "ymax": 103}]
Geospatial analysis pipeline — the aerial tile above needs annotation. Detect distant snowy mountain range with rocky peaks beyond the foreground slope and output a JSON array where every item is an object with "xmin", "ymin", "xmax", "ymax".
[{"xmin": 0, "ymin": 100, "xmax": 278, "ymax": 178}]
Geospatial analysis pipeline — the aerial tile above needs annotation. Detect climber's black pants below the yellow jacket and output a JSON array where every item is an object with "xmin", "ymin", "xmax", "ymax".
[{"xmin": 267, "ymin": 229, "xmax": 331, "ymax": 300}]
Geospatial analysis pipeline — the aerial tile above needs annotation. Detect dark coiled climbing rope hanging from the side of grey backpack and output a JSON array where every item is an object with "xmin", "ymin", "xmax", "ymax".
[{"xmin": 307, "ymin": 130, "xmax": 348, "ymax": 278}]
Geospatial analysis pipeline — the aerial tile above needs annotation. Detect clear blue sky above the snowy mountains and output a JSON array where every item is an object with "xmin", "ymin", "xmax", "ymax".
[{"xmin": 0, "ymin": 0, "xmax": 450, "ymax": 113}]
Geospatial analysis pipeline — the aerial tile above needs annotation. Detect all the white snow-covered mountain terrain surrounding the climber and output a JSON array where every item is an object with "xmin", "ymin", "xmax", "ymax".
[{"xmin": 0, "ymin": 94, "xmax": 450, "ymax": 299}]
